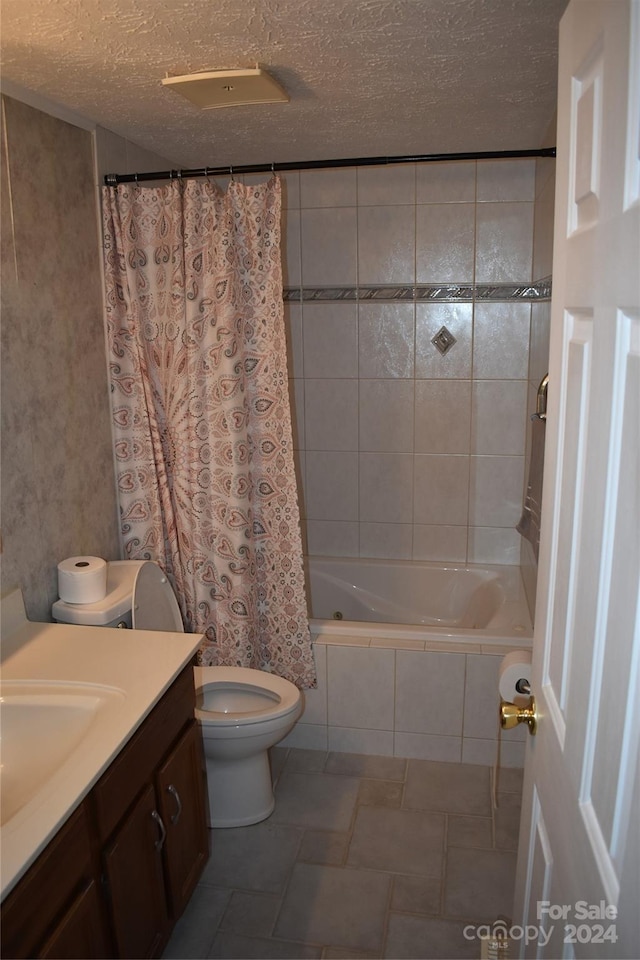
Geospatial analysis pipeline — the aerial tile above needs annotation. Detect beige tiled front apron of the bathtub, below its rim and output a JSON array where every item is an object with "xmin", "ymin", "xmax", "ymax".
[{"xmin": 282, "ymin": 622, "xmax": 531, "ymax": 767}]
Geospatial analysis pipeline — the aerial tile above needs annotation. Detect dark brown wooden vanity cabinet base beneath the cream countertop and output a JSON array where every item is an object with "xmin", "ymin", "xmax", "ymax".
[{"xmin": 2, "ymin": 666, "xmax": 209, "ymax": 960}]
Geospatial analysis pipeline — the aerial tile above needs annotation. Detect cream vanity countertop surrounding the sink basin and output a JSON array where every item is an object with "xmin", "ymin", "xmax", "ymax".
[{"xmin": 0, "ymin": 595, "xmax": 202, "ymax": 897}]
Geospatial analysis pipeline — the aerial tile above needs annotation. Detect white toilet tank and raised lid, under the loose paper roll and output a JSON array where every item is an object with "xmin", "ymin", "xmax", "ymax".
[{"xmin": 51, "ymin": 560, "xmax": 184, "ymax": 633}]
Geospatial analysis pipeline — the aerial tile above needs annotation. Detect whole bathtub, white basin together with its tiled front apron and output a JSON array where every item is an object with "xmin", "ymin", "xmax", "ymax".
[{"xmin": 281, "ymin": 557, "xmax": 532, "ymax": 767}]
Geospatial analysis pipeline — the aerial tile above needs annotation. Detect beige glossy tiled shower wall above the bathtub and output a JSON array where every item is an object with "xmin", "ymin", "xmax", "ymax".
[{"xmin": 284, "ymin": 160, "xmax": 542, "ymax": 563}]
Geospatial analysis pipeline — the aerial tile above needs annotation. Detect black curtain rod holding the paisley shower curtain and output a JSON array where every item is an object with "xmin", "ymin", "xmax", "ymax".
[{"xmin": 104, "ymin": 147, "xmax": 556, "ymax": 187}]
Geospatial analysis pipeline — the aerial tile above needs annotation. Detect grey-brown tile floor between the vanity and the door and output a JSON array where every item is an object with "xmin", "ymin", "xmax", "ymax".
[{"xmin": 163, "ymin": 748, "xmax": 522, "ymax": 960}]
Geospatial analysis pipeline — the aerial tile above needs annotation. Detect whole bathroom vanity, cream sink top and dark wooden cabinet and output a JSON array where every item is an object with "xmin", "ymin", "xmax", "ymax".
[{"xmin": 0, "ymin": 596, "xmax": 209, "ymax": 958}]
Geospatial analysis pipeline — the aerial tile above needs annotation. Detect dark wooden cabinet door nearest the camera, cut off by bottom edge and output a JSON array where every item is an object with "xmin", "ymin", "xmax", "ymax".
[{"xmin": 38, "ymin": 880, "xmax": 110, "ymax": 960}]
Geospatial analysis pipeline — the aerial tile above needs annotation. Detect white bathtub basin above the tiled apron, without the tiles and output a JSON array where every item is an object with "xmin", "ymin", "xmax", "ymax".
[{"xmin": 307, "ymin": 557, "xmax": 532, "ymax": 644}]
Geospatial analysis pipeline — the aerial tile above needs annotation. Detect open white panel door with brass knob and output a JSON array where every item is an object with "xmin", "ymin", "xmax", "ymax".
[{"xmin": 515, "ymin": 0, "xmax": 640, "ymax": 958}]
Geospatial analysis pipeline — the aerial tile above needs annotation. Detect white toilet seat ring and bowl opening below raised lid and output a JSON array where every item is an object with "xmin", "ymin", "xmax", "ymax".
[{"xmin": 194, "ymin": 667, "xmax": 300, "ymax": 727}]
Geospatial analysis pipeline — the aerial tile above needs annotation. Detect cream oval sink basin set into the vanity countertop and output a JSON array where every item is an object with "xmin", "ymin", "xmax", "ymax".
[{"xmin": 0, "ymin": 681, "xmax": 124, "ymax": 824}]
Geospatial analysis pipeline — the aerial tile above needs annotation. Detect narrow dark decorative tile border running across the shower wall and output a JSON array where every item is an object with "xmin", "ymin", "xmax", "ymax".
[{"xmin": 284, "ymin": 277, "xmax": 551, "ymax": 303}]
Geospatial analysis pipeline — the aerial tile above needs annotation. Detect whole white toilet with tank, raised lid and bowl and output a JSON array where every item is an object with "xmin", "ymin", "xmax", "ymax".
[{"xmin": 52, "ymin": 560, "xmax": 302, "ymax": 827}]
